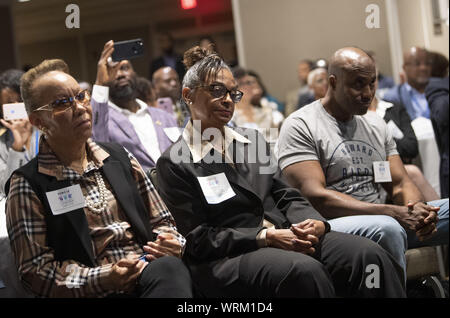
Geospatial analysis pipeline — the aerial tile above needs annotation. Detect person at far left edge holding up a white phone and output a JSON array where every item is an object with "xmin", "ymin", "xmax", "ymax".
[{"xmin": 0, "ymin": 69, "xmax": 40, "ymax": 198}]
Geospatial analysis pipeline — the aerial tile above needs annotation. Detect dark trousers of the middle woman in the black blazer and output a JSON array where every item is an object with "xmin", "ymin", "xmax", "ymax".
[{"xmin": 190, "ymin": 232, "xmax": 406, "ymax": 298}]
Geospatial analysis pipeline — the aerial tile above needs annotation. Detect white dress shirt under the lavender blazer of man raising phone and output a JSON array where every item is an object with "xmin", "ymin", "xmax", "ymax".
[{"xmin": 109, "ymin": 98, "xmax": 161, "ymax": 162}]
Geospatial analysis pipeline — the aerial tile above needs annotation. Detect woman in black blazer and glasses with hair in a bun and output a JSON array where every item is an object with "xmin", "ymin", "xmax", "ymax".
[{"xmin": 157, "ymin": 47, "xmax": 405, "ymax": 297}]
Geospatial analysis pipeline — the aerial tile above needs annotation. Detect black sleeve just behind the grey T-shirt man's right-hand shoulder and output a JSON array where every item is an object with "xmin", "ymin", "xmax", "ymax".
[{"xmin": 384, "ymin": 104, "xmax": 419, "ymax": 163}]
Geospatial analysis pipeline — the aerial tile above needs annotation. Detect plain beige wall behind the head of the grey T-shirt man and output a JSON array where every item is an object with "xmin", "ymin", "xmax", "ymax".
[{"xmin": 233, "ymin": 0, "xmax": 391, "ymax": 100}]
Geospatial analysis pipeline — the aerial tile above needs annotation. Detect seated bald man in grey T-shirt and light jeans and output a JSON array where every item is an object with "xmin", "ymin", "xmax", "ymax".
[{"xmin": 278, "ymin": 48, "xmax": 448, "ymax": 278}]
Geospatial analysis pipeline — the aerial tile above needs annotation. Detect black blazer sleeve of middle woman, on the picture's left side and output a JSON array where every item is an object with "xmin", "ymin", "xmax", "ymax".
[{"xmin": 156, "ymin": 153, "xmax": 263, "ymax": 262}]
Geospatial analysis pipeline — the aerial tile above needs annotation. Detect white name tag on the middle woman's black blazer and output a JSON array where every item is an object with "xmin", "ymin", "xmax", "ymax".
[{"xmin": 197, "ymin": 172, "xmax": 236, "ymax": 204}]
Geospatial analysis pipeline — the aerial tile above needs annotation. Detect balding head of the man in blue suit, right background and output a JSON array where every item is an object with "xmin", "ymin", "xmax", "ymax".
[{"xmin": 403, "ymin": 46, "xmax": 431, "ymax": 92}]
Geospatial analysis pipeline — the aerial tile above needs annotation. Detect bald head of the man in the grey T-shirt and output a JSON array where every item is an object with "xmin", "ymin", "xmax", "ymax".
[{"xmin": 326, "ymin": 47, "xmax": 376, "ymax": 120}]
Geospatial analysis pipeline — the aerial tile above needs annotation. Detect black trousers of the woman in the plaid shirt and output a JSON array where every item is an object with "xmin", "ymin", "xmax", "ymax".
[{"xmin": 136, "ymin": 256, "xmax": 192, "ymax": 298}]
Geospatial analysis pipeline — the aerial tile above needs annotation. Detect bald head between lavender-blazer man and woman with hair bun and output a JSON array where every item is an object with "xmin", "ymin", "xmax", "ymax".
[{"xmin": 152, "ymin": 66, "xmax": 181, "ymax": 103}]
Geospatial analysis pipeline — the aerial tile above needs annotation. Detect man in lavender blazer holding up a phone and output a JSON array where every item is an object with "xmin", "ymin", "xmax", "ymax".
[{"xmin": 92, "ymin": 41, "xmax": 179, "ymax": 171}]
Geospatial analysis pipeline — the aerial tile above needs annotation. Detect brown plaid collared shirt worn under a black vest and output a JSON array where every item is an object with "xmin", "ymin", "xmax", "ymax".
[{"xmin": 6, "ymin": 138, "xmax": 185, "ymax": 297}]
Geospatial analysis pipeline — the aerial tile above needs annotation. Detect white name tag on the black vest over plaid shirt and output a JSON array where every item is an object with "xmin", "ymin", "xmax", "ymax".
[{"xmin": 45, "ymin": 184, "xmax": 86, "ymax": 215}]
